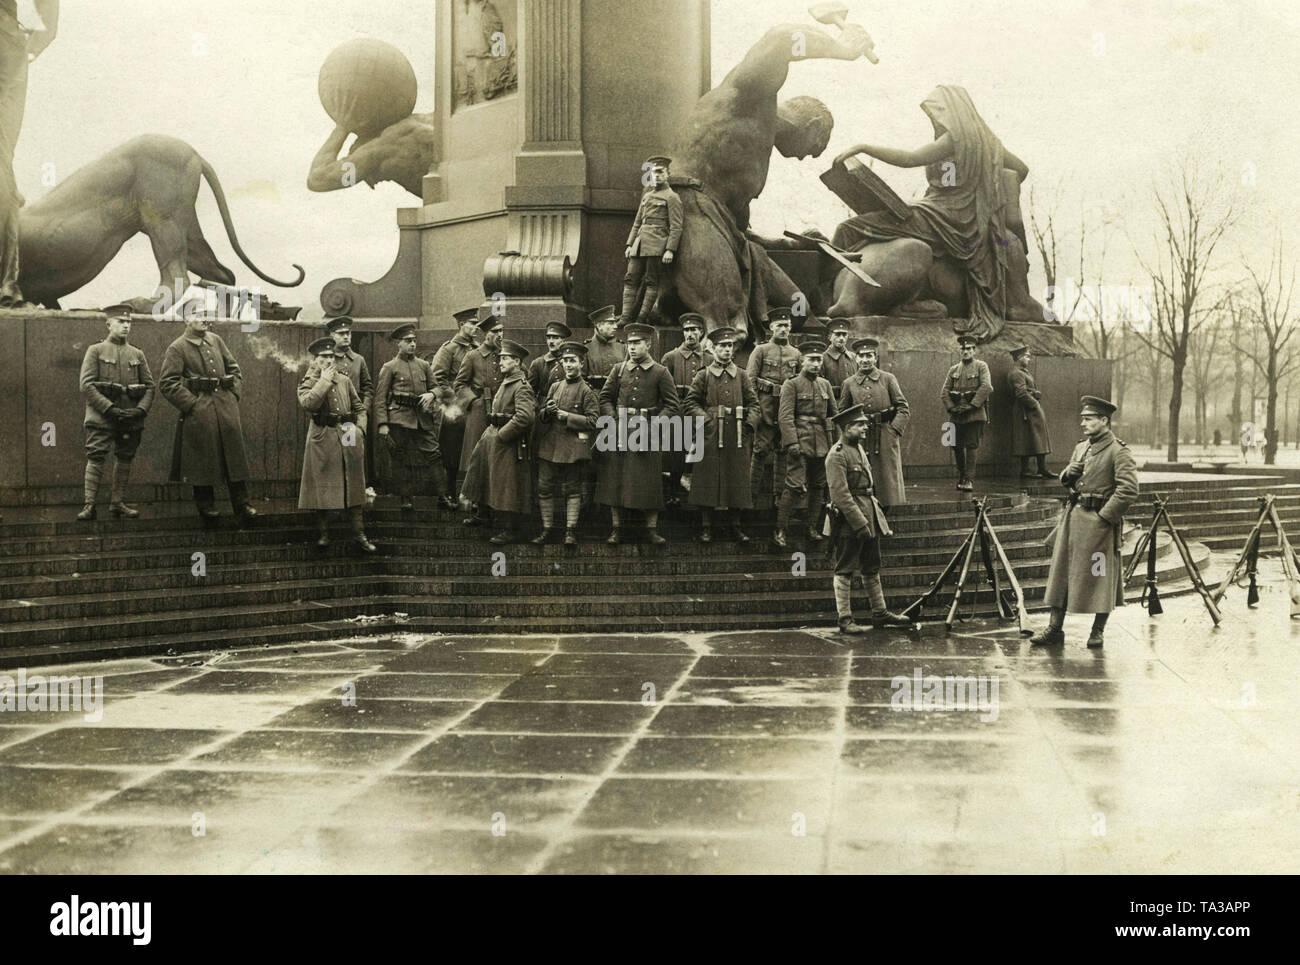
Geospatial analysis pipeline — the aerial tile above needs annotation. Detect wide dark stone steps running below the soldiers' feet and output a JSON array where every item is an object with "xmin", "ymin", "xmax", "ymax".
[{"xmin": 0, "ymin": 478, "xmax": 1222, "ymax": 666}]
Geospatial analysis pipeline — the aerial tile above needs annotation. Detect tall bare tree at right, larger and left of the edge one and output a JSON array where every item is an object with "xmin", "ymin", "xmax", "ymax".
[{"xmin": 1134, "ymin": 160, "xmax": 1238, "ymax": 462}]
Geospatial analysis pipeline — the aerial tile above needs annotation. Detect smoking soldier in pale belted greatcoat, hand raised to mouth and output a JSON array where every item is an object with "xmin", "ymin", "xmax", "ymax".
[{"xmin": 298, "ymin": 336, "xmax": 374, "ymax": 553}]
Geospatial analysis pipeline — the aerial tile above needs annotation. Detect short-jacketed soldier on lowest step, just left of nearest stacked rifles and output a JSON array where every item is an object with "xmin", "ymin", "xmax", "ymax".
[{"xmin": 826, "ymin": 406, "xmax": 911, "ymax": 633}]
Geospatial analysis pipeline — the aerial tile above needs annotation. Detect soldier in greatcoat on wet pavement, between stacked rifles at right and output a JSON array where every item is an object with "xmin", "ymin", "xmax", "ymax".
[{"xmin": 1030, "ymin": 395, "xmax": 1138, "ymax": 648}]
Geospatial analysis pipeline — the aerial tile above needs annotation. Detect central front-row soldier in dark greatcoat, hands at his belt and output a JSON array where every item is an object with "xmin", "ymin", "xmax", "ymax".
[{"xmin": 595, "ymin": 323, "xmax": 677, "ymax": 546}]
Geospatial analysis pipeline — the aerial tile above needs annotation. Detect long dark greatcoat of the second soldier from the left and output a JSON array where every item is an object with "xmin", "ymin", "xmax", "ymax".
[{"xmin": 159, "ymin": 332, "xmax": 248, "ymax": 486}]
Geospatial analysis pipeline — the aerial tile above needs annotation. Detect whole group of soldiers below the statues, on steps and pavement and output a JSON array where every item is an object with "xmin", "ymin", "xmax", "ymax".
[{"xmin": 78, "ymin": 306, "xmax": 1136, "ymax": 645}]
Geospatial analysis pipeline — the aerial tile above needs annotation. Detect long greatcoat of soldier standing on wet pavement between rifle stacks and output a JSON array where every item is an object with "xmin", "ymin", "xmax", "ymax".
[{"xmin": 1045, "ymin": 429, "xmax": 1138, "ymax": 613}]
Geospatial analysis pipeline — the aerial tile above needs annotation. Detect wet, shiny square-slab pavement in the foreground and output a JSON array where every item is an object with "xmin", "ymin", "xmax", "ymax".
[{"xmin": 0, "ymin": 564, "xmax": 1300, "ymax": 874}]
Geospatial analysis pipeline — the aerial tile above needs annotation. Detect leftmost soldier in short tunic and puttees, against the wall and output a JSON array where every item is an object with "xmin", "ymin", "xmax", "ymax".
[{"xmin": 77, "ymin": 304, "xmax": 155, "ymax": 520}]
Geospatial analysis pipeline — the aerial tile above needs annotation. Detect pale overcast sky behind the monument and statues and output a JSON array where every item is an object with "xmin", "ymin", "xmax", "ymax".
[{"xmin": 16, "ymin": 0, "xmax": 1300, "ymax": 313}]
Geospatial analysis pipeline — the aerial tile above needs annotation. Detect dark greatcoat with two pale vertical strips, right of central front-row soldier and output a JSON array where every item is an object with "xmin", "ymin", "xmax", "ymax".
[{"xmin": 683, "ymin": 362, "xmax": 762, "ymax": 510}]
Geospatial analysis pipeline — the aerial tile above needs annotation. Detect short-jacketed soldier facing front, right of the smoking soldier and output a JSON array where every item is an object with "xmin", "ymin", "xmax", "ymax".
[{"xmin": 374, "ymin": 325, "xmax": 447, "ymax": 511}]
